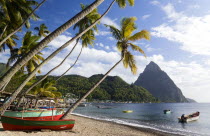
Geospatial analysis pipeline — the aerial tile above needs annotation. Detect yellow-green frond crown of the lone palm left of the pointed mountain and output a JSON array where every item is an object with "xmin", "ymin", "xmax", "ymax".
[{"xmin": 105, "ymin": 17, "xmax": 150, "ymax": 74}]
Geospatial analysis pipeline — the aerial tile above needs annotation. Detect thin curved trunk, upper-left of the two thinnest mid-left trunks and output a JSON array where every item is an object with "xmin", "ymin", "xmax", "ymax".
[{"xmin": 21, "ymin": 38, "xmax": 80, "ymax": 96}]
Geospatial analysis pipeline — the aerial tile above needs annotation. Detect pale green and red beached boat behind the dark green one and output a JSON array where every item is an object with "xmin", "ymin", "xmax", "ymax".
[{"xmin": 4, "ymin": 110, "xmax": 64, "ymax": 120}]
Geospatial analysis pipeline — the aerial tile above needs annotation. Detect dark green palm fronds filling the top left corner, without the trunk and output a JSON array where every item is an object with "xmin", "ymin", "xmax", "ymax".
[{"xmin": 0, "ymin": 0, "xmax": 39, "ymax": 51}]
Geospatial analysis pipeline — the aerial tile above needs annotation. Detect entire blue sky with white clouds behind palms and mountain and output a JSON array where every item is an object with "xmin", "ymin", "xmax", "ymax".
[{"xmin": 0, "ymin": 0, "xmax": 210, "ymax": 102}]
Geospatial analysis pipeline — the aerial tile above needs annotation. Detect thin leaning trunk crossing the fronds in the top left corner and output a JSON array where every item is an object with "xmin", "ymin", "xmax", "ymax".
[{"xmin": 0, "ymin": 0, "xmax": 46, "ymax": 47}]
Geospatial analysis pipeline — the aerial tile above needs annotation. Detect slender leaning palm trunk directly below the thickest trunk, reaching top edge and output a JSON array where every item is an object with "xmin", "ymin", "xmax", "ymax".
[{"xmin": 1, "ymin": 0, "xmax": 115, "ymax": 115}]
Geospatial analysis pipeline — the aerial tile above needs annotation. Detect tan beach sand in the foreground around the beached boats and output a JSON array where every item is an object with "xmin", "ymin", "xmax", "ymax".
[{"xmin": 0, "ymin": 115, "xmax": 177, "ymax": 136}]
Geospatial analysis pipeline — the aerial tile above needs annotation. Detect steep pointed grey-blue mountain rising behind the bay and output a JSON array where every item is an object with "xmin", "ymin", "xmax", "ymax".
[{"xmin": 134, "ymin": 61, "xmax": 188, "ymax": 102}]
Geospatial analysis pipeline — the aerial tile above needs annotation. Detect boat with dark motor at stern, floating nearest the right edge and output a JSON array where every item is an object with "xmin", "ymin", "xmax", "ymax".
[{"xmin": 178, "ymin": 112, "xmax": 200, "ymax": 123}]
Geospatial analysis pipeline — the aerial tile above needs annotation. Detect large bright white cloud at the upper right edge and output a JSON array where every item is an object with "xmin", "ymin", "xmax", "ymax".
[{"xmin": 152, "ymin": 4, "xmax": 210, "ymax": 56}]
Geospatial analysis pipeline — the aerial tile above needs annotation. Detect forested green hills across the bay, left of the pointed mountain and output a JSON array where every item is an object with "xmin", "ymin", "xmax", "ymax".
[{"xmin": 45, "ymin": 75, "xmax": 157, "ymax": 102}]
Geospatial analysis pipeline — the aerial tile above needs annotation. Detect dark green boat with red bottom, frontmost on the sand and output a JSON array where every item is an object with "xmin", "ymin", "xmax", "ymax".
[{"xmin": 1, "ymin": 116, "xmax": 75, "ymax": 130}]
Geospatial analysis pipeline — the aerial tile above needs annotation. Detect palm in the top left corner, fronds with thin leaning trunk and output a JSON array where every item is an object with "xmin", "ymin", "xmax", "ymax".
[{"xmin": 0, "ymin": 0, "xmax": 46, "ymax": 47}]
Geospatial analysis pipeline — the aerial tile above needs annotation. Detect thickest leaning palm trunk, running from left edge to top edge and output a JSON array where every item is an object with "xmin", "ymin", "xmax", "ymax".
[{"xmin": 0, "ymin": 0, "xmax": 104, "ymax": 91}]
